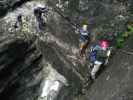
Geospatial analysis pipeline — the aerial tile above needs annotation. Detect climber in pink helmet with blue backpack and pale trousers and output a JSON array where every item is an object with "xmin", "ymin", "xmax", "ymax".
[{"xmin": 89, "ymin": 40, "xmax": 109, "ymax": 80}]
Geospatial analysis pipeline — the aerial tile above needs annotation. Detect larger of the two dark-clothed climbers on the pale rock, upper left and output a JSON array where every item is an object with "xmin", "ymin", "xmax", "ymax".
[{"xmin": 34, "ymin": 5, "xmax": 48, "ymax": 31}]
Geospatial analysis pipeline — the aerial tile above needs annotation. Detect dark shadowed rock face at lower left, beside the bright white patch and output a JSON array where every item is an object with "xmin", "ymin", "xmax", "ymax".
[{"xmin": 0, "ymin": 35, "xmax": 43, "ymax": 100}]
